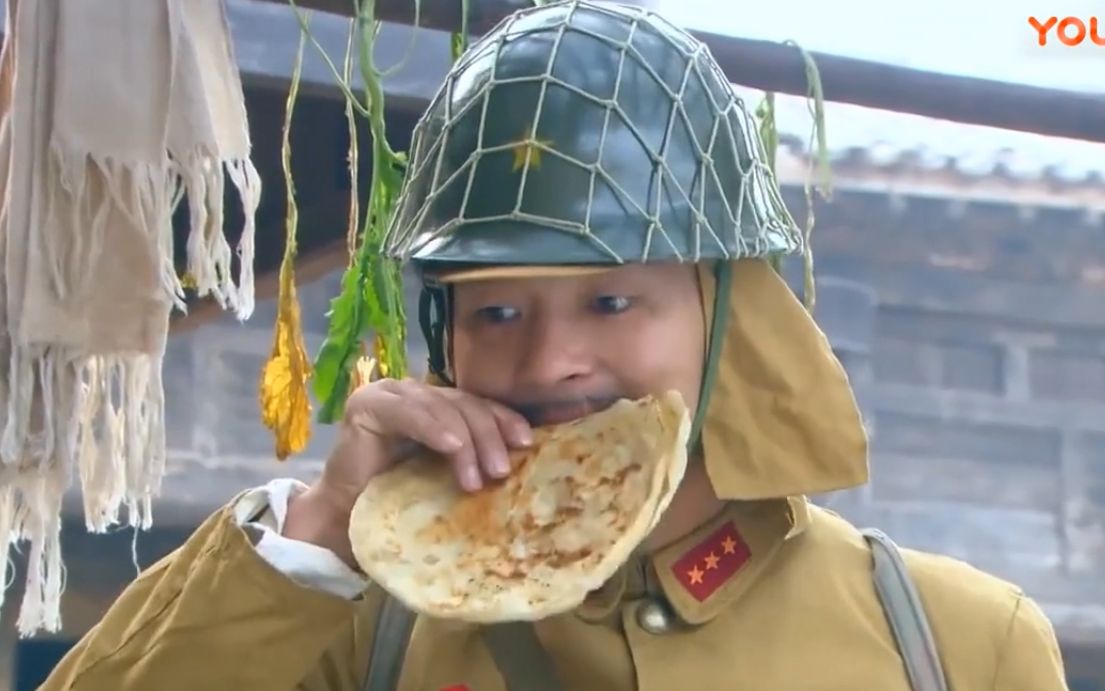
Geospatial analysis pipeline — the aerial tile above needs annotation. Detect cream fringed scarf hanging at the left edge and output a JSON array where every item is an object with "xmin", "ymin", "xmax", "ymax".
[{"xmin": 0, "ymin": 0, "xmax": 260, "ymax": 635}]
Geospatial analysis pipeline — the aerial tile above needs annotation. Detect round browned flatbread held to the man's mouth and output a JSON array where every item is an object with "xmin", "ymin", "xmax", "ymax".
[{"xmin": 349, "ymin": 391, "xmax": 691, "ymax": 624}]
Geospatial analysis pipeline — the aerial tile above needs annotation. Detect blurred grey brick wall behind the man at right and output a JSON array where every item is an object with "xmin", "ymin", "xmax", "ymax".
[{"xmin": 788, "ymin": 184, "xmax": 1105, "ymax": 645}]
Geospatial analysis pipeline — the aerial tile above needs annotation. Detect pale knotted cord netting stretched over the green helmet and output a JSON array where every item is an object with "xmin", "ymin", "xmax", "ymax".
[{"xmin": 386, "ymin": 0, "xmax": 803, "ymax": 263}]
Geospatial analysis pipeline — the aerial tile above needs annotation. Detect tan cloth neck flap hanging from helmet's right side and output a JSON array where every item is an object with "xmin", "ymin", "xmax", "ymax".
[{"xmin": 696, "ymin": 259, "xmax": 869, "ymax": 500}]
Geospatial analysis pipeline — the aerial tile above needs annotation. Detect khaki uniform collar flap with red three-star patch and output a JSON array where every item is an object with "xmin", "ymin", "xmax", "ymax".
[{"xmin": 651, "ymin": 496, "xmax": 810, "ymax": 625}]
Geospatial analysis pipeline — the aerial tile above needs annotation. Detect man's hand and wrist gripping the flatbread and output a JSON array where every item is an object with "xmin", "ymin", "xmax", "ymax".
[{"xmin": 284, "ymin": 379, "xmax": 533, "ymax": 566}]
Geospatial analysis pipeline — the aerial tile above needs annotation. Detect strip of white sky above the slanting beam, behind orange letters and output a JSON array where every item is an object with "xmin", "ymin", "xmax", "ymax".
[{"xmin": 655, "ymin": 0, "xmax": 1105, "ymax": 93}]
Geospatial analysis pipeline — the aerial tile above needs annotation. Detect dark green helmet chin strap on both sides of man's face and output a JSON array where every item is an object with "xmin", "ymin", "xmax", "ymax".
[{"xmin": 418, "ymin": 260, "xmax": 733, "ymax": 452}]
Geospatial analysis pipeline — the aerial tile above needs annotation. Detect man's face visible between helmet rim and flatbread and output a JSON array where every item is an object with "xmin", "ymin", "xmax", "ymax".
[{"xmin": 451, "ymin": 264, "xmax": 705, "ymax": 426}]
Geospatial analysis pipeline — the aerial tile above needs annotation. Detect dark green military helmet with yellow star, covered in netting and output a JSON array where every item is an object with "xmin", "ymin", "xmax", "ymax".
[{"xmin": 385, "ymin": 0, "xmax": 802, "ymax": 270}]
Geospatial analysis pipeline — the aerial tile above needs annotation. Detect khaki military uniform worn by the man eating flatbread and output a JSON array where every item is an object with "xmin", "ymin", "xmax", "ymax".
[{"xmin": 42, "ymin": 484, "xmax": 1065, "ymax": 691}]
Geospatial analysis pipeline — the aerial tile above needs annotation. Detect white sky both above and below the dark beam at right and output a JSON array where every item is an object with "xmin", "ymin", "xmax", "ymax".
[{"xmin": 650, "ymin": 0, "xmax": 1105, "ymax": 179}]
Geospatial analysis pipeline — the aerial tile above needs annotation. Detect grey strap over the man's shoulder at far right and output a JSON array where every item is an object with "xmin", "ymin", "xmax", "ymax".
[{"xmin": 862, "ymin": 528, "xmax": 948, "ymax": 691}]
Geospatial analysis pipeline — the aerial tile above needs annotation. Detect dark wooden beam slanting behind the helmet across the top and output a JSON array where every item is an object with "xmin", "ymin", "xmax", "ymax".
[{"xmin": 264, "ymin": 0, "xmax": 1105, "ymax": 142}]
